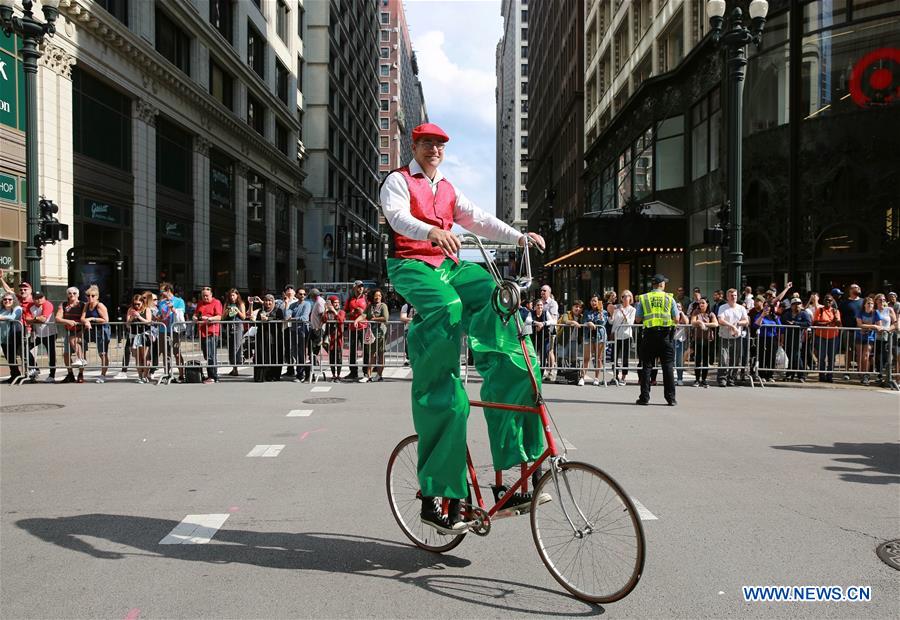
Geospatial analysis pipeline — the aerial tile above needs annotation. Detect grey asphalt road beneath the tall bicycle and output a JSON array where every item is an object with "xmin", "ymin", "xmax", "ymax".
[{"xmin": 0, "ymin": 380, "xmax": 900, "ymax": 620}]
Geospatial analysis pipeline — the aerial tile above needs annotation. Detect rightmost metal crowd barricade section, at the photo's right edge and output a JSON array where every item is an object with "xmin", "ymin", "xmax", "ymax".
[{"xmin": 756, "ymin": 325, "xmax": 898, "ymax": 387}]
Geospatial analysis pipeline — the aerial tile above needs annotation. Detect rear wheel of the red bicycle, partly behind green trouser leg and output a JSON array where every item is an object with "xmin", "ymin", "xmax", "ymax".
[{"xmin": 387, "ymin": 435, "xmax": 465, "ymax": 553}]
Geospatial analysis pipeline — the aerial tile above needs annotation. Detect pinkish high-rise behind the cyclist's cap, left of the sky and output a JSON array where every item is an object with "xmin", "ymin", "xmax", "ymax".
[{"xmin": 378, "ymin": 0, "xmax": 428, "ymax": 177}]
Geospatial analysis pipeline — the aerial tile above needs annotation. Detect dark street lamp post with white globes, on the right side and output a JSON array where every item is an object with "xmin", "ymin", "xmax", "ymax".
[{"xmin": 706, "ymin": 0, "xmax": 769, "ymax": 288}]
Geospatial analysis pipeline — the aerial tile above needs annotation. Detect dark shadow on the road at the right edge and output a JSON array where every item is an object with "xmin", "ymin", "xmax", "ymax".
[{"xmin": 772, "ymin": 442, "xmax": 900, "ymax": 484}]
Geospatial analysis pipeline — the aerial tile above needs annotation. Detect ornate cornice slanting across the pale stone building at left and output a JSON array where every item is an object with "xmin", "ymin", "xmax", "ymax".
[{"xmin": 59, "ymin": 0, "xmax": 306, "ymax": 190}]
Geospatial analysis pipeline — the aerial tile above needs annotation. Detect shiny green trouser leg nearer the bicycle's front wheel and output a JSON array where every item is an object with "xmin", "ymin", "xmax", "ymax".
[{"xmin": 450, "ymin": 262, "xmax": 544, "ymax": 470}]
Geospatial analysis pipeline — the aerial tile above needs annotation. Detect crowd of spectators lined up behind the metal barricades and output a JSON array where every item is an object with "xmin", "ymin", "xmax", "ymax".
[{"xmin": 0, "ymin": 273, "xmax": 900, "ymax": 388}]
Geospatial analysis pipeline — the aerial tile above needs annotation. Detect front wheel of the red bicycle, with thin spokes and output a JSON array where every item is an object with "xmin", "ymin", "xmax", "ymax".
[{"xmin": 531, "ymin": 462, "xmax": 645, "ymax": 603}]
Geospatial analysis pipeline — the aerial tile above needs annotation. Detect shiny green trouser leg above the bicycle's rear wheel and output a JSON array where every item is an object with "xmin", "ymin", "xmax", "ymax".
[{"xmin": 387, "ymin": 259, "xmax": 469, "ymax": 499}]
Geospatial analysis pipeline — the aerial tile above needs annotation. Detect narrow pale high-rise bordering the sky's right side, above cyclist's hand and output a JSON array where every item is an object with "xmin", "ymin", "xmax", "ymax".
[{"xmin": 497, "ymin": 0, "xmax": 528, "ymax": 230}]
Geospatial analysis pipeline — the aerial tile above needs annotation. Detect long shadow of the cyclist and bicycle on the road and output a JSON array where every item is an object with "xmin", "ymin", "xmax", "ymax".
[{"xmin": 16, "ymin": 514, "xmax": 603, "ymax": 617}]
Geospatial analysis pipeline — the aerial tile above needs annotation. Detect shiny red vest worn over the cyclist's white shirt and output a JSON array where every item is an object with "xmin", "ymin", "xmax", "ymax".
[{"xmin": 394, "ymin": 166, "xmax": 459, "ymax": 267}]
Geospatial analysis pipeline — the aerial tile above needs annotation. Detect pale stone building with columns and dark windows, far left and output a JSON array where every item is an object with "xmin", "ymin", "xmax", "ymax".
[{"xmin": 0, "ymin": 0, "xmax": 309, "ymax": 305}]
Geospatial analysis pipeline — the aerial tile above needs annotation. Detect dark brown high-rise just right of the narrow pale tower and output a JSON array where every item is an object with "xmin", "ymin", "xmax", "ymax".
[{"xmin": 522, "ymin": 0, "xmax": 585, "ymax": 299}]
